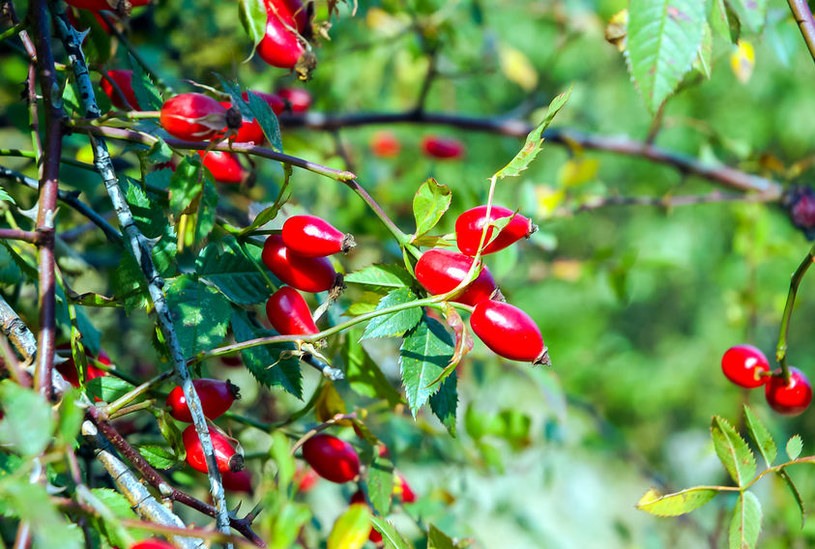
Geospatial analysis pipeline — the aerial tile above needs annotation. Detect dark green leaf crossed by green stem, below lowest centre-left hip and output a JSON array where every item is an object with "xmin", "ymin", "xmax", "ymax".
[{"xmin": 231, "ymin": 311, "xmax": 303, "ymax": 398}]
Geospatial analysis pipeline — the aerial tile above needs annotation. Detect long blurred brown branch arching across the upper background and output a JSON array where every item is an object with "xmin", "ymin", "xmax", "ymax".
[{"xmin": 280, "ymin": 111, "xmax": 782, "ymax": 201}]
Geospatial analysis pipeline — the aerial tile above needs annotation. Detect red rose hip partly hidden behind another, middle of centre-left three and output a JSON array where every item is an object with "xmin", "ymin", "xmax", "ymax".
[{"xmin": 261, "ymin": 234, "xmax": 337, "ymax": 293}]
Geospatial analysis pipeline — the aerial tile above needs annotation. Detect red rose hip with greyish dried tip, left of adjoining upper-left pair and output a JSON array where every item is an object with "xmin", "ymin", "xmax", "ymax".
[{"xmin": 159, "ymin": 93, "xmax": 227, "ymax": 141}]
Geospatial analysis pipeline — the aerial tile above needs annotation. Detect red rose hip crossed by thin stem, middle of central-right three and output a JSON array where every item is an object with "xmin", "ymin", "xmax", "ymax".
[{"xmin": 415, "ymin": 248, "xmax": 496, "ymax": 306}]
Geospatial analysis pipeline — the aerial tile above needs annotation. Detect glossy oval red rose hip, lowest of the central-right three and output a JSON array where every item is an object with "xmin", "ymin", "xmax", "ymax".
[{"xmin": 470, "ymin": 301, "xmax": 546, "ymax": 363}]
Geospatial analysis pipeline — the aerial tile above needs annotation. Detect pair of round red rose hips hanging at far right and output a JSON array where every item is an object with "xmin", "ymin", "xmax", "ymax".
[{"xmin": 722, "ymin": 345, "xmax": 812, "ymax": 416}]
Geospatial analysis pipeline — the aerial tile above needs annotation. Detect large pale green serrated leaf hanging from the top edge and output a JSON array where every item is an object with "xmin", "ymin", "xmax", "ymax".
[{"xmin": 625, "ymin": 0, "xmax": 705, "ymax": 114}]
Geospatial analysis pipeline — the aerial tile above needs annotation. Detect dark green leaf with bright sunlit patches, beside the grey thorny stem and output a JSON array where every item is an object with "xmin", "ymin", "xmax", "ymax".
[{"xmin": 164, "ymin": 275, "xmax": 232, "ymax": 358}]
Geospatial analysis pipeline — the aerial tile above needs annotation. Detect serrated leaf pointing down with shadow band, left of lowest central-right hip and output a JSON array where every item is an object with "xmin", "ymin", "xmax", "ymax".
[{"xmin": 399, "ymin": 316, "xmax": 454, "ymax": 417}]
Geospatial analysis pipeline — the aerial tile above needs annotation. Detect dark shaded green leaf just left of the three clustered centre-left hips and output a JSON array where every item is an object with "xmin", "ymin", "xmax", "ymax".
[{"xmin": 195, "ymin": 236, "xmax": 273, "ymax": 305}]
